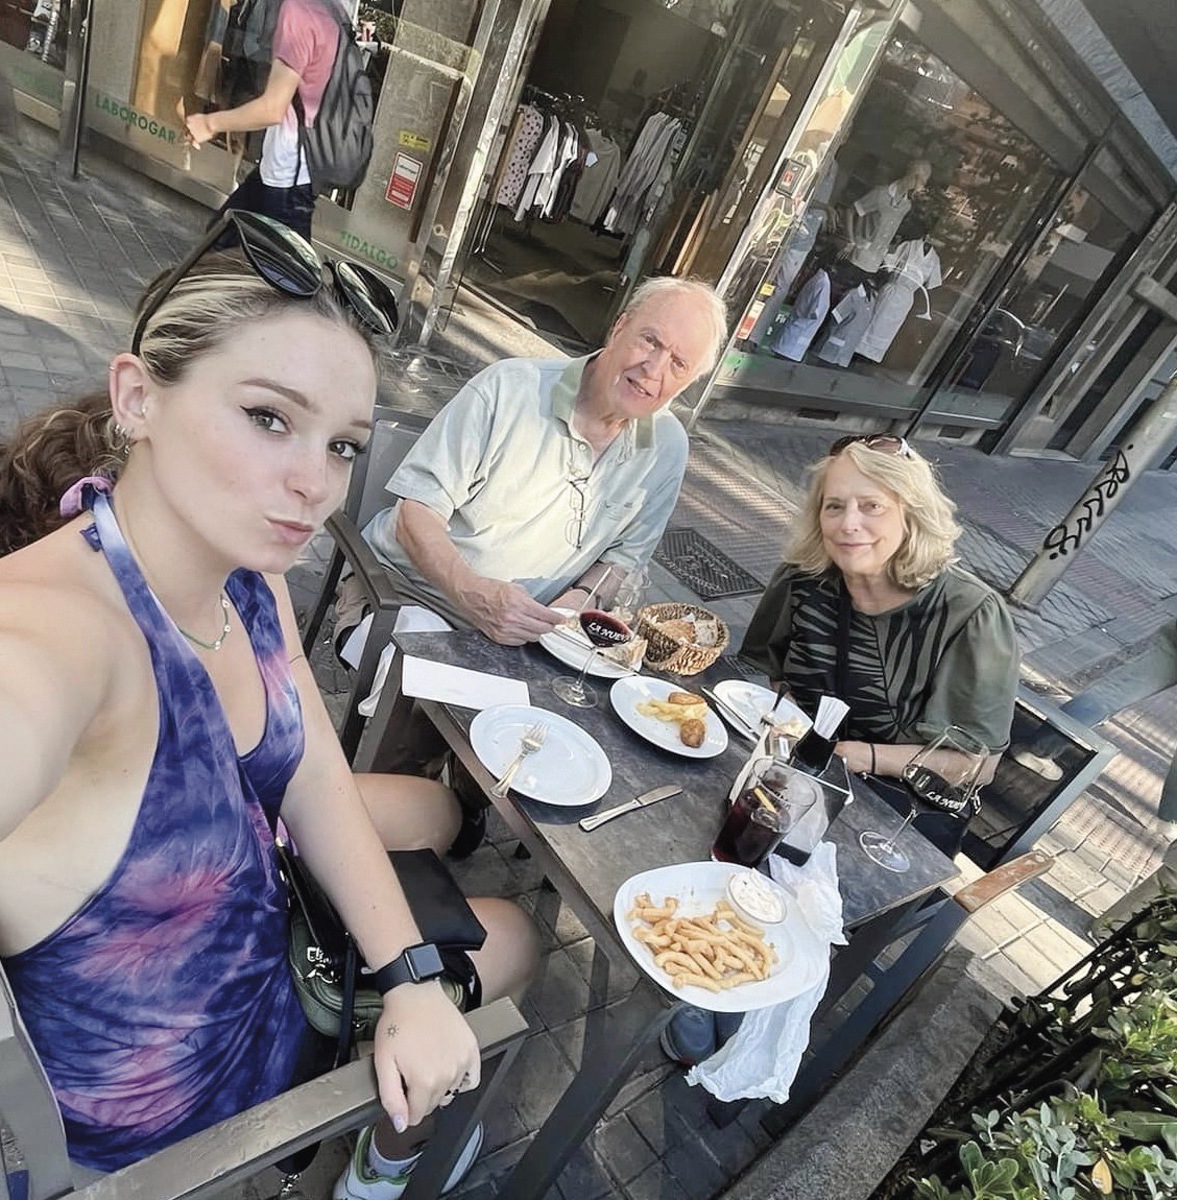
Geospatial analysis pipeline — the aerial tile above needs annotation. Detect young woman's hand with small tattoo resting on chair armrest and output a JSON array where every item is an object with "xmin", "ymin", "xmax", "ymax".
[{"xmin": 376, "ymin": 980, "xmax": 482, "ymax": 1133}]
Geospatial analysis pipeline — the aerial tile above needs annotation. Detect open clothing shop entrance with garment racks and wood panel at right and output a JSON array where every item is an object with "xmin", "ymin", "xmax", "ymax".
[{"xmin": 453, "ymin": 0, "xmax": 801, "ymax": 350}]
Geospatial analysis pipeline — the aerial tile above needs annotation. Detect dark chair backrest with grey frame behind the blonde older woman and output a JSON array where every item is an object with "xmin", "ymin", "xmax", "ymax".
[{"xmin": 961, "ymin": 688, "xmax": 1116, "ymax": 871}]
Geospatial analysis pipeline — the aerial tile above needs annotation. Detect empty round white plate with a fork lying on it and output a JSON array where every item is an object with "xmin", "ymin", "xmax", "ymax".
[{"xmin": 470, "ymin": 704, "xmax": 613, "ymax": 806}]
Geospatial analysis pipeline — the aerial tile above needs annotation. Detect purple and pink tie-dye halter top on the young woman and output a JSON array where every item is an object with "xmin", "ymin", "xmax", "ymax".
[{"xmin": 4, "ymin": 488, "xmax": 310, "ymax": 1171}]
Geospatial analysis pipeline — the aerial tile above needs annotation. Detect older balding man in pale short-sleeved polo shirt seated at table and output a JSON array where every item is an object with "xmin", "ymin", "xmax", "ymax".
[{"xmin": 341, "ymin": 278, "xmax": 726, "ymax": 646}]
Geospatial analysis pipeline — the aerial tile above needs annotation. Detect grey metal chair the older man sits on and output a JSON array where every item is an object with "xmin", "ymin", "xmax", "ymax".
[{"xmin": 302, "ymin": 406, "xmax": 430, "ymax": 762}]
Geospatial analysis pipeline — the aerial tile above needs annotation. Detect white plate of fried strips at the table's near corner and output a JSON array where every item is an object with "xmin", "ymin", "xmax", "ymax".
[{"xmin": 613, "ymin": 863, "xmax": 828, "ymax": 1013}]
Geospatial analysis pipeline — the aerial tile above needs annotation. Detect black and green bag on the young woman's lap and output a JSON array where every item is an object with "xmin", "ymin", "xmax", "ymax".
[{"xmin": 276, "ymin": 841, "xmax": 486, "ymax": 1066}]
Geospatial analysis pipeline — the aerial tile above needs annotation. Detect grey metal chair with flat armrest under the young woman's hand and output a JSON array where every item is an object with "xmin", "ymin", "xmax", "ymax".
[{"xmin": 0, "ymin": 971, "xmax": 528, "ymax": 1200}]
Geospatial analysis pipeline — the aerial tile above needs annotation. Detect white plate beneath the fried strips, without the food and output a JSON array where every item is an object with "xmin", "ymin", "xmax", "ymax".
[{"xmin": 613, "ymin": 863, "xmax": 829, "ymax": 1013}]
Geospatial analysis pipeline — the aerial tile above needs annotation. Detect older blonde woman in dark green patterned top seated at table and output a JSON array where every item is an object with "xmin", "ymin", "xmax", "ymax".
[{"xmin": 740, "ymin": 434, "xmax": 1017, "ymax": 796}]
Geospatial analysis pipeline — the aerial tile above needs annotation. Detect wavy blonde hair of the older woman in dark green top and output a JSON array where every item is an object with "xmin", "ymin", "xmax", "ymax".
[{"xmin": 785, "ymin": 442, "xmax": 961, "ymax": 590}]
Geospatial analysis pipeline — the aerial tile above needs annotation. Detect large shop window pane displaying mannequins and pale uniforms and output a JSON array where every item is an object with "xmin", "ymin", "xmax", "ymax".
[{"xmin": 740, "ymin": 32, "xmax": 1058, "ymax": 422}]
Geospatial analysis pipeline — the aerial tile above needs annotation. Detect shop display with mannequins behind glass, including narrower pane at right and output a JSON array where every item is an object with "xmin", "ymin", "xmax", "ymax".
[{"xmin": 738, "ymin": 31, "xmax": 1133, "ymax": 427}]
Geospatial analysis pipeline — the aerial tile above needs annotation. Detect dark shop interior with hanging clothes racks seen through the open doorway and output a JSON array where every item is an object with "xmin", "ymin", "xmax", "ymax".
[{"xmin": 453, "ymin": 0, "xmax": 734, "ymax": 352}]
